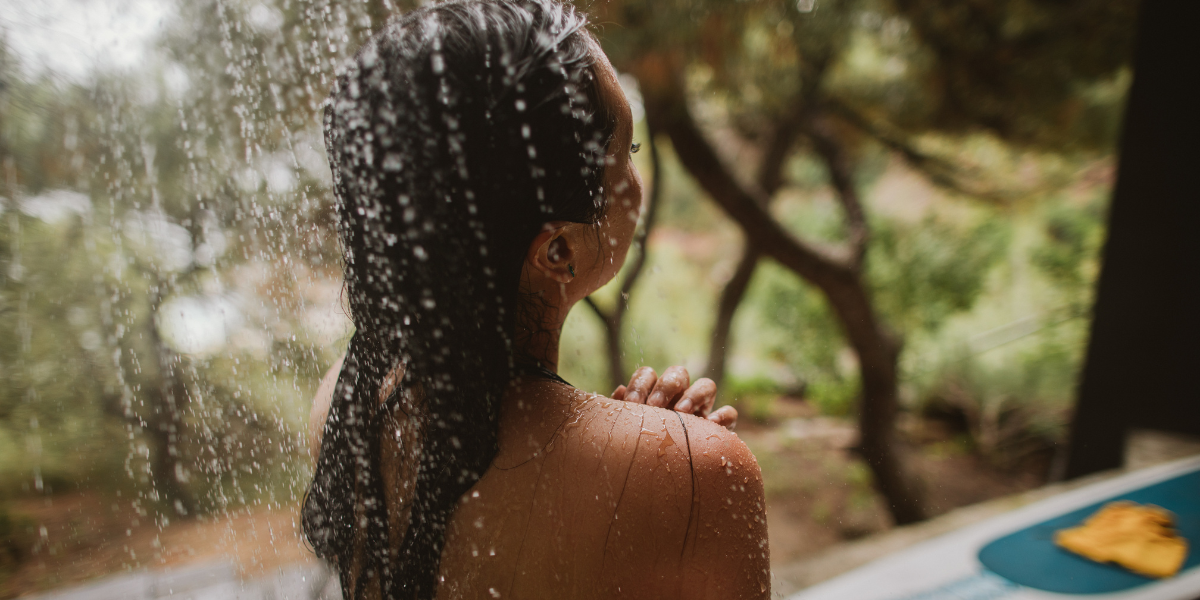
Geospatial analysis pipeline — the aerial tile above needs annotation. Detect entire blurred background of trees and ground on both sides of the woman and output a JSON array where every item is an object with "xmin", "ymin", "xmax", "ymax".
[{"xmin": 0, "ymin": 0, "xmax": 1138, "ymax": 598}]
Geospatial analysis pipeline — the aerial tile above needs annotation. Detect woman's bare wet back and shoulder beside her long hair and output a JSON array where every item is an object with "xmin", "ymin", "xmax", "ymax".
[{"xmin": 438, "ymin": 382, "xmax": 769, "ymax": 599}]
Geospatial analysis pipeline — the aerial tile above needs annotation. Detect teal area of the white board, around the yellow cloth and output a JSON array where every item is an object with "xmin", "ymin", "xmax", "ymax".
[{"xmin": 979, "ymin": 470, "xmax": 1200, "ymax": 594}]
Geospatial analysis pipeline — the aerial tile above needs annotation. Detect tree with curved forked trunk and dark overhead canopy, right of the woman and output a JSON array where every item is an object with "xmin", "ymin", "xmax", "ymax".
[{"xmin": 601, "ymin": 0, "xmax": 1135, "ymax": 523}]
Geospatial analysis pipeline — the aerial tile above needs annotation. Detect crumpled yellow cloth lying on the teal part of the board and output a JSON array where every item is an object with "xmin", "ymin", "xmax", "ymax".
[{"xmin": 1054, "ymin": 500, "xmax": 1188, "ymax": 577}]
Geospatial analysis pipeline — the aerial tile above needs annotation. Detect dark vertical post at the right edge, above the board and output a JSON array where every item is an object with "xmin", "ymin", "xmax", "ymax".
[{"xmin": 1066, "ymin": 0, "xmax": 1200, "ymax": 478}]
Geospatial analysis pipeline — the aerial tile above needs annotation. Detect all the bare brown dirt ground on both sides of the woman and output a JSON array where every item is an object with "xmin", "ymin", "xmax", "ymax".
[{"xmin": 0, "ymin": 400, "xmax": 1046, "ymax": 598}]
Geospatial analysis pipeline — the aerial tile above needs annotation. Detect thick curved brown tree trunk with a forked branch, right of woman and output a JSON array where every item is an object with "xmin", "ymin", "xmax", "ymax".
[{"xmin": 636, "ymin": 54, "xmax": 926, "ymax": 524}]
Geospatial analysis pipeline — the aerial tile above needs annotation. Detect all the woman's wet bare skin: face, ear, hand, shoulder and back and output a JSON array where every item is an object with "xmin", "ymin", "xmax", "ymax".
[{"xmin": 311, "ymin": 38, "xmax": 769, "ymax": 599}]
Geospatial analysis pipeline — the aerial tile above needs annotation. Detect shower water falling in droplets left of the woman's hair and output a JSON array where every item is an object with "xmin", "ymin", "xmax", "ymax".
[{"xmin": 0, "ymin": 0, "xmax": 391, "ymax": 590}]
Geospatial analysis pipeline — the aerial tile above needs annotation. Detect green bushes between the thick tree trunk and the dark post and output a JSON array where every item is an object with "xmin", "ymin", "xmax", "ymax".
[{"xmin": 906, "ymin": 186, "xmax": 1106, "ymax": 466}]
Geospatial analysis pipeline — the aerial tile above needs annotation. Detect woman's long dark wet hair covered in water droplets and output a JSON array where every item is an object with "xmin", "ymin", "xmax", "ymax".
[{"xmin": 302, "ymin": 0, "xmax": 614, "ymax": 599}]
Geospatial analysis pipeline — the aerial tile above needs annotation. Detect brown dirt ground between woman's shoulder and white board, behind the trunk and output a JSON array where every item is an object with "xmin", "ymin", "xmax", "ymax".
[{"xmin": 738, "ymin": 400, "xmax": 1049, "ymax": 565}]
